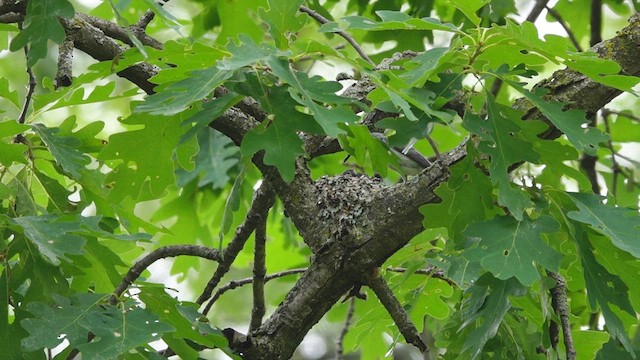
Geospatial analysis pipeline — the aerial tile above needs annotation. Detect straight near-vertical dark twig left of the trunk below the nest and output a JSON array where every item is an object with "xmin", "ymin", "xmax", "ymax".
[{"xmin": 249, "ymin": 217, "xmax": 267, "ymax": 332}]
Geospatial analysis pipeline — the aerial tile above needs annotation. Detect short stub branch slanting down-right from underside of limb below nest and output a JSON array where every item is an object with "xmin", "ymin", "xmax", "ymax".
[{"xmin": 366, "ymin": 276, "xmax": 428, "ymax": 354}]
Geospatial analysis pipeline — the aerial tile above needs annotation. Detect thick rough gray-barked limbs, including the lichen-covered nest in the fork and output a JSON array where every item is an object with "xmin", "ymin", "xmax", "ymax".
[{"xmin": 0, "ymin": 1, "xmax": 640, "ymax": 359}]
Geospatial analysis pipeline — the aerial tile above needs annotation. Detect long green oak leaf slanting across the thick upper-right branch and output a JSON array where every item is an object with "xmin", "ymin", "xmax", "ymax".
[{"xmin": 504, "ymin": 79, "xmax": 609, "ymax": 155}]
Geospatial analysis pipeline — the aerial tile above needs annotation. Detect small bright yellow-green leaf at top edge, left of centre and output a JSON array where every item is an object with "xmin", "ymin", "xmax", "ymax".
[{"xmin": 258, "ymin": 0, "xmax": 308, "ymax": 49}]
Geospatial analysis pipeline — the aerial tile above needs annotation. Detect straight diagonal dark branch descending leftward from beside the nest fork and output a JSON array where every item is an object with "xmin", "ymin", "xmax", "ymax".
[{"xmin": 196, "ymin": 182, "xmax": 275, "ymax": 308}]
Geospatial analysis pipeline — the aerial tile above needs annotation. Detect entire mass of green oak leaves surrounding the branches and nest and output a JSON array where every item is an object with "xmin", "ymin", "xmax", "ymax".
[{"xmin": 0, "ymin": 0, "xmax": 640, "ymax": 359}]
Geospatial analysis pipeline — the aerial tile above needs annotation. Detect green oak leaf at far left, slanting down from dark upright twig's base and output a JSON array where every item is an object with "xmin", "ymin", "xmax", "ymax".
[{"xmin": 32, "ymin": 124, "xmax": 91, "ymax": 180}]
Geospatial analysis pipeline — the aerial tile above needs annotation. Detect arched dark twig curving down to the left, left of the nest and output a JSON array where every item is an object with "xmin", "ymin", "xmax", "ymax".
[{"xmin": 109, "ymin": 245, "xmax": 222, "ymax": 304}]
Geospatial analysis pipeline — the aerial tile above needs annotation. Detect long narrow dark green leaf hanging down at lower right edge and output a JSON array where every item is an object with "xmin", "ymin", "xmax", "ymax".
[{"xmin": 574, "ymin": 223, "xmax": 636, "ymax": 353}]
